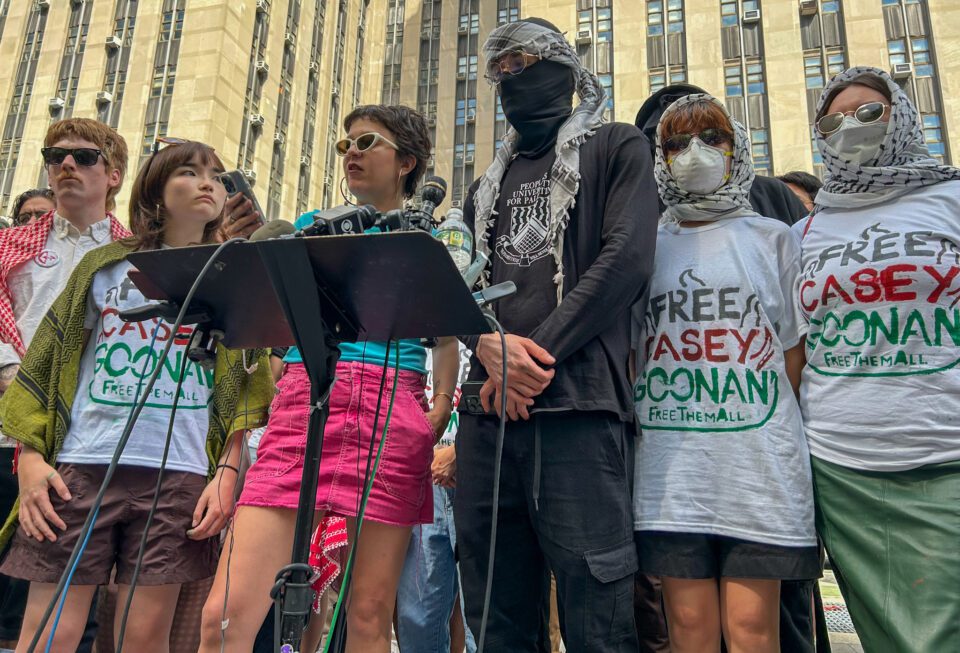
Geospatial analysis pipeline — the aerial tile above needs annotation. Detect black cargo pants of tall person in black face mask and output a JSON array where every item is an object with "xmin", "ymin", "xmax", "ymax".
[{"xmin": 454, "ymin": 412, "xmax": 637, "ymax": 653}]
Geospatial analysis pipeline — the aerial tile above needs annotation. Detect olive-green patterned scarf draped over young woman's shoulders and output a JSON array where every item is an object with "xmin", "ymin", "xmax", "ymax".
[{"xmin": 0, "ymin": 242, "xmax": 274, "ymax": 550}]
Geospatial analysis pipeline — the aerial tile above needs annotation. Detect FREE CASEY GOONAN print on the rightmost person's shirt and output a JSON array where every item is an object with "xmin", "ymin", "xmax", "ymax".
[{"xmin": 800, "ymin": 223, "xmax": 960, "ymax": 376}]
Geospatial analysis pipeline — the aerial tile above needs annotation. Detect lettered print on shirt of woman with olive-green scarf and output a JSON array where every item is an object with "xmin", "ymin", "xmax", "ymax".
[{"xmin": 86, "ymin": 276, "xmax": 214, "ymax": 410}]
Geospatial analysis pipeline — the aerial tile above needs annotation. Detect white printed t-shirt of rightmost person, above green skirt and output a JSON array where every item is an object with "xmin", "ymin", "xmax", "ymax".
[{"xmin": 798, "ymin": 181, "xmax": 960, "ymax": 472}]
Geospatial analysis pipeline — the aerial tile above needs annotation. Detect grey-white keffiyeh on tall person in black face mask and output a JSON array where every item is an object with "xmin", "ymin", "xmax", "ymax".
[{"xmin": 473, "ymin": 21, "xmax": 606, "ymax": 304}]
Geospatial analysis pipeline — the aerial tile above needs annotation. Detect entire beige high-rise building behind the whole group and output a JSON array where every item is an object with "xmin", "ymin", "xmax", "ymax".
[{"xmin": 0, "ymin": 0, "xmax": 960, "ymax": 219}]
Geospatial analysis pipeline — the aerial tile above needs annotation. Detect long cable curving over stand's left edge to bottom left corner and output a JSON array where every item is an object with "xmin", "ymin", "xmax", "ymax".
[{"xmin": 27, "ymin": 238, "xmax": 246, "ymax": 653}]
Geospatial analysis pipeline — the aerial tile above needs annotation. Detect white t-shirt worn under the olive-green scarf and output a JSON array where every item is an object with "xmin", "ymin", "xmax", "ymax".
[{"xmin": 57, "ymin": 261, "xmax": 213, "ymax": 476}]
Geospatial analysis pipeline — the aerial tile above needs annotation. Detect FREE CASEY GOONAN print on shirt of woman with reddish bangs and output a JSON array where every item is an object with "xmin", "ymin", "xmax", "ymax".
[{"xmin": 634, "ymin": 269, "xmax": 782, "ymax": 433}]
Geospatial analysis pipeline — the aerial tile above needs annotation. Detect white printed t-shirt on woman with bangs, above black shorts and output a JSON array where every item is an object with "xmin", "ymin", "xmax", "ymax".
[{"xmin": 633, "ymin": 216, "xmax": 816, "ymax": 546}]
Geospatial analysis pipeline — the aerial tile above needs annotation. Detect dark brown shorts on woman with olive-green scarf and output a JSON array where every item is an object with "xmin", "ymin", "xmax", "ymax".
[{"xmin": 0, "ymin": 463, "xmax": 219, "ymax": 585}]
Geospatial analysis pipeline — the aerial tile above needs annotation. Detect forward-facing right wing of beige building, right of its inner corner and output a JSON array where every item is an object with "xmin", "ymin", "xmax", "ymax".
[{"xmin": 381, "ymin": 0, "xmax": 960, "ymax": 203}]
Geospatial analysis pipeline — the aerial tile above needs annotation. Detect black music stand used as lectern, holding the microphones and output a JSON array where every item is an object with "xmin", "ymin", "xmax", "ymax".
[{"xmin": 128, "ymin": 232, "xmax": 491, "ymax": 651}]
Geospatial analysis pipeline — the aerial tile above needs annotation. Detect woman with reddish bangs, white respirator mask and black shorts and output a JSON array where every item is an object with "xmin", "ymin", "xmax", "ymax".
[{"xmin": 634, "ymin": 94, "xmax": 820, "ymax": 653}]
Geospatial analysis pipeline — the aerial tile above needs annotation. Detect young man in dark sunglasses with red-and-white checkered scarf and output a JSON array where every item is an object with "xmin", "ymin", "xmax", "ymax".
[{"xmin": 0, "ymin": 118, "xmax": 130, "ymax": 640}]
